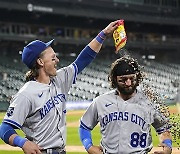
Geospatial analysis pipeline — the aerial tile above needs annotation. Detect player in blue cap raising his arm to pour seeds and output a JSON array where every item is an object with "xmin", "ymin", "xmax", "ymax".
[{"xmin": 0, "ymin": 21, "xmax": 118, "ymax": 154}]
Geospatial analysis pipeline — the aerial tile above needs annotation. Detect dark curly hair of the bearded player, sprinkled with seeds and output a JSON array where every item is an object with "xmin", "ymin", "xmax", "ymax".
[{"xmin": 108, "ymin": 55, "xmax": 144, "ymax": 88}]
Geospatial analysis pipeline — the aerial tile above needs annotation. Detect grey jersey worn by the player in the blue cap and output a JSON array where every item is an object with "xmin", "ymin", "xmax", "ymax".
[{"xmin": 4, "ymin": 64, "xmax": 77, "ymax": 149}]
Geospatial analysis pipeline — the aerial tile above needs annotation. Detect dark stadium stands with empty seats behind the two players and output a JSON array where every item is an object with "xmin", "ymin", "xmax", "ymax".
[{"xmin": 0, "ymin": 0, "xmax": 180, "ymax": 153}]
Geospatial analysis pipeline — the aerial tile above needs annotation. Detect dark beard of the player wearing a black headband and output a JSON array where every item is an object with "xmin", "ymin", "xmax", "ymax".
[{"xmin": 117, "ymin": 85, "xmax": 137, "ymax": 95}]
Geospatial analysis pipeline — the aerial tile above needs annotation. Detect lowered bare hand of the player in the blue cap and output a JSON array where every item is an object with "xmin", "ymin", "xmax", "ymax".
[{"xmin": 22, "ymin": 141, "xmax": 43, "ymax": 154}]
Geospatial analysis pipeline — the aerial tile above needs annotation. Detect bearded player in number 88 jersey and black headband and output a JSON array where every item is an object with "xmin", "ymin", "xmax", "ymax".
[{"xmin": 79, "ymin": 56, "xmax": 172, "ymax": 154}]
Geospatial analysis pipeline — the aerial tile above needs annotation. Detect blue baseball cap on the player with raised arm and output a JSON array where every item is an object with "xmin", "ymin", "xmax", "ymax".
[{"xmin": 22, "ymin": 39, "xmax": 54, "ymax": 69}]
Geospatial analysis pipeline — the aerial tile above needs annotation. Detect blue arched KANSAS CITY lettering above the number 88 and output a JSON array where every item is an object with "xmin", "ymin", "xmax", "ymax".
[{"xmin": 101, "ymin": 112, "xmax": 146, "ymax": 129}]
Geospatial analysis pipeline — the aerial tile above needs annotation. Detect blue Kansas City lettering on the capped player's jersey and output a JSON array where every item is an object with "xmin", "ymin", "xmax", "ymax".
[{"xmin": 39, "ymin": 94, "xmax": 66, "ymax": 119}]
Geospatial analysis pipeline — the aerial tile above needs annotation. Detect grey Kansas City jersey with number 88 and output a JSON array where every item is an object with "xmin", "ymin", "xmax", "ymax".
[{"xmin": 81, "ymin": 90, "xmax": 168, "ymax": 154}]
